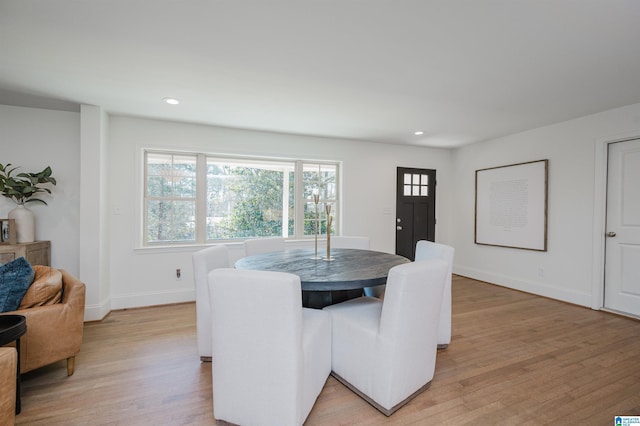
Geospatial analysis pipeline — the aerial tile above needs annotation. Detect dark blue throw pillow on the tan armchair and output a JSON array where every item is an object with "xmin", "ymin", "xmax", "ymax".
[{"xmin": 0, "ymin": 257, "xmax": 34, "ymax": 312}]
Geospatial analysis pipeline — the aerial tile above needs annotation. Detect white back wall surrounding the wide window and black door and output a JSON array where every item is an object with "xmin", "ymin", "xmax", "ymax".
[{"xmin": 108, "ymin": 116, "xmax": 451, "ymax": 309}]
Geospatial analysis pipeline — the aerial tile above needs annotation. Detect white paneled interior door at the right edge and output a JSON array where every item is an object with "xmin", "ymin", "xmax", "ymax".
[{"xmin": 604, "ymin": 139, "xmax": 640, "ymax": 317}]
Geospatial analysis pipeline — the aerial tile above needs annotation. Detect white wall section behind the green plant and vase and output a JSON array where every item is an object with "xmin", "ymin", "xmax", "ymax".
[{"xmin": 0, "ymin": 105, "xmax": 80, "ymax": 276}]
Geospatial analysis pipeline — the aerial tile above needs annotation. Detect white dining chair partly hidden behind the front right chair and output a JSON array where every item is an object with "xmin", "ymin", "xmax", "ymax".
[{"xmin": 415, "ymin": 240, "xmax": 455, "ymax": 349}]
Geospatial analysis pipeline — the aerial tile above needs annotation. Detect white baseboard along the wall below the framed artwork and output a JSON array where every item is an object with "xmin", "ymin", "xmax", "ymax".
[{"xmin": 453, "ymin": 265, "xmax": 591, "ymax": 307}]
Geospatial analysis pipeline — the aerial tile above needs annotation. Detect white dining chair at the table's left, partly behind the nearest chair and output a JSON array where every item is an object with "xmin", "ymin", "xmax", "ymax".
[{"xmin": 191, "ymin": 246, "xmax": 230, "ymax": 362}]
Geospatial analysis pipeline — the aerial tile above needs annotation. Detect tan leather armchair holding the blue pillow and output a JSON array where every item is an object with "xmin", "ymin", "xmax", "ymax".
[{"xmin": 0, "ymin": 269, "xmax": 86, "ymax": 376}]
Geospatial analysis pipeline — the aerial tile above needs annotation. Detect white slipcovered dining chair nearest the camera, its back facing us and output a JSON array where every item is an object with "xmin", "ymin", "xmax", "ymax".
[{"xmin": 209, "ymin": 269, "xmax": 331, "ymax": 426}]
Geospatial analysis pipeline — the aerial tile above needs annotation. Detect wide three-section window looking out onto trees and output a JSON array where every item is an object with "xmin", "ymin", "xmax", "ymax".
[{"xmin": 144, "ymin": 151, "xmax": 339, "ymax": 246}]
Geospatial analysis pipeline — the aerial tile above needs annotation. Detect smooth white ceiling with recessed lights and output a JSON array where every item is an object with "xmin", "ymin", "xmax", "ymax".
[{"xmin": 0, "ymin": 0, "xmax": 640, "ymax": 147}]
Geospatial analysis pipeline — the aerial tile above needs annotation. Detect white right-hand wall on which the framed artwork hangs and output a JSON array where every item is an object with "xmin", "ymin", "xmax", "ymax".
[{"xmin": 451, "ymin": 104, "xmax": 640, "ymax": 308}]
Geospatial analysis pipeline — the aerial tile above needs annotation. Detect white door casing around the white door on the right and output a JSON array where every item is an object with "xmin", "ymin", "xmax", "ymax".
[{"xmin": 591, "ymin": 130, "xmax": 640, "ymax": 309}]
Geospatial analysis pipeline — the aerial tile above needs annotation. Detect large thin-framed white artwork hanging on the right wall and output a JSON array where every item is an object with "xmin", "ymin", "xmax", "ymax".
[{"xmin": 474, "ymin": 159, "xmax": 549, "ymax": 251}]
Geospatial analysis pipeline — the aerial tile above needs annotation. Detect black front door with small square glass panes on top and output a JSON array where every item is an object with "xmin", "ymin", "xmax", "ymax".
[{"xmin": 396, "ymin": 167, "xmax": 436, "ymax": 260}]
